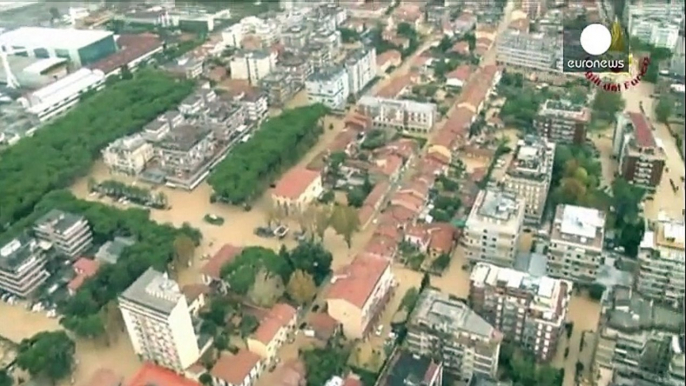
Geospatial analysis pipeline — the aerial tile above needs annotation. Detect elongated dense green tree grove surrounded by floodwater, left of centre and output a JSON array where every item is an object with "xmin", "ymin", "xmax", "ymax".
[{"xmin": 207, "ymin": 104, "xmax": 328, "ymax": 204}]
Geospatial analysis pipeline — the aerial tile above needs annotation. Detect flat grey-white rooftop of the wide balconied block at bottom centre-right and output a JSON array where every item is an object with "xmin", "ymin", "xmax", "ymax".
[{"xmin": 410, "ymin": 289, "xmax": 500, "ymax": 340}]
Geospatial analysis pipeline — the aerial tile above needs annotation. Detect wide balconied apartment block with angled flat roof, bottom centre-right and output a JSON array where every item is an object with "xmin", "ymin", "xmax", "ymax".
[{"xmin": 406, "ymin": 289, "xmax": 502, "ymax": 382}]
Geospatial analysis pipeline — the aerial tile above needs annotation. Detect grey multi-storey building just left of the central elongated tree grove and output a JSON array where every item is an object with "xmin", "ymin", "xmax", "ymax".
[{"xmin": 155, "ymin": 124, "xmax": 217, "ymax": 190}]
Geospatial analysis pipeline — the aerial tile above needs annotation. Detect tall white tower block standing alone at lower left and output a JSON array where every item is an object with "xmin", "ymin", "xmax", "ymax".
[{"xmin": 119, "ymin": 268, "xmax": 204, "ymax": 372}]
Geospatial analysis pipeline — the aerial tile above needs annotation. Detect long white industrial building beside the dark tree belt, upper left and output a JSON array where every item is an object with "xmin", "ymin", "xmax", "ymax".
[{"xmin": 18, "ymin": 68, "xmax": 105, "ymax": 122}]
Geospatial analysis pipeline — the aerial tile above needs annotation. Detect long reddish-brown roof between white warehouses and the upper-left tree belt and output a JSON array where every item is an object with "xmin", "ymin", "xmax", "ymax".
[{"xmin": 89, "ymin": 34, "xmax": 162, "ymax": 74}]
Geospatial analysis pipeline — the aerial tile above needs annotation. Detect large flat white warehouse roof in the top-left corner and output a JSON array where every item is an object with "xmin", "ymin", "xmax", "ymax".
[{"xmin": 0, "ymin": 27, "xmax": 113, "ymax": 50}]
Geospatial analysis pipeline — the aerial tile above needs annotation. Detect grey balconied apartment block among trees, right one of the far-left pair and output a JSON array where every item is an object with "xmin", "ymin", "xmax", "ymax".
[{"xmin": 33, "ymin": 209, "xmax": 93, "ymax": 258}]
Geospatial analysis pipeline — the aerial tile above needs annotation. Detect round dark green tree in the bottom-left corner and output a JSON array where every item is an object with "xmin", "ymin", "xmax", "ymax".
[{"xmin": 17, "ymin": 331, "xmax": 76, "ymax": 384}]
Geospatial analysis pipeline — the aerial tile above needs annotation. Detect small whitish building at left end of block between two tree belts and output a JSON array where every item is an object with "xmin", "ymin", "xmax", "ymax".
[{"xmin": 102, "ymin": 134, "xmax": 155, "ymax": 176}]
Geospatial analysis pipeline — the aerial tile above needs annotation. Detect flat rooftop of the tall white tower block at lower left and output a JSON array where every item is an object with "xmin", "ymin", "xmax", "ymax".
[{"xmin": 120, "ymin": 268, "xmax": 184, "ymax": 314}]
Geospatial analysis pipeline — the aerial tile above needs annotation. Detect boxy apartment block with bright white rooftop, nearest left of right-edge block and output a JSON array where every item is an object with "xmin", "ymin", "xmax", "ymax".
[{"xmin": 547, "ymin": 205, "xmax": 605, "ymax": 283}]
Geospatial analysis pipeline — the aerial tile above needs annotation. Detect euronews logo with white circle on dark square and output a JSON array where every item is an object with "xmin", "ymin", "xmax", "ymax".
[{"xmin": 563, "ymin": 19, "xmax": 631, "ymax": 74}]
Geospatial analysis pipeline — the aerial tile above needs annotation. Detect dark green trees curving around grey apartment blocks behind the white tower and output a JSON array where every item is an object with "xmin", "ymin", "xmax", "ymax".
[{"xmin": 3, "ymin": 190, "xmax": 202, "ymax": 339}]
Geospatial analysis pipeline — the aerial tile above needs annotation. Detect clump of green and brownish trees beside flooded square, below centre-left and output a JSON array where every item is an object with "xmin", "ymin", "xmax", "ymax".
[{"xmin": 221, "ymin": 241, "xmax": 333, "ymax": 307}]
